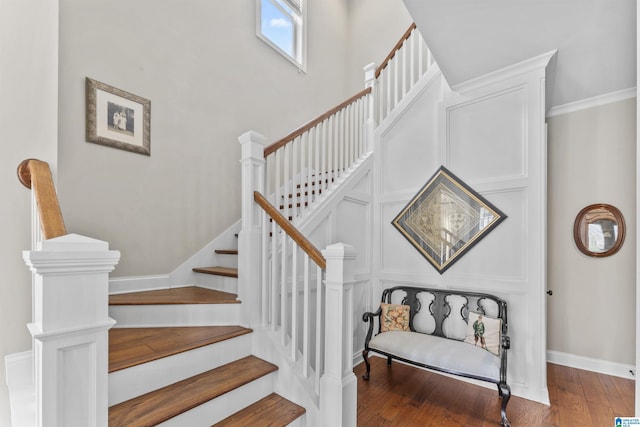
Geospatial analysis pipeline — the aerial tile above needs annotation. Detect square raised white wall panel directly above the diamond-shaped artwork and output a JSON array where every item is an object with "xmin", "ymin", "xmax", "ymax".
[{"xmin": 447, "ymin": 87, "xmax": 527, "ymax": 184}]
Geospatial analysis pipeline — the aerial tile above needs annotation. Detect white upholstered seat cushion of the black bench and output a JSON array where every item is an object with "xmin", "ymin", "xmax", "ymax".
[{"xmin": 369, "ymin": 331, "xmax": 500, "ymax": 383}]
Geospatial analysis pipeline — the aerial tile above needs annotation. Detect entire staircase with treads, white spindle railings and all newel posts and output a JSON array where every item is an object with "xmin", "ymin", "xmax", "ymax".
[{"xmin": 7, "ymin": 26, "xmax": 431, "ymax": 427}]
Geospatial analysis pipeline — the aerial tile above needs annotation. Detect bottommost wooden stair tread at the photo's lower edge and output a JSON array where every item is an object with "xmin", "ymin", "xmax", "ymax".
[{"xmin": 212, "ymin": 393, "xmax": 306, "ymax": 427}]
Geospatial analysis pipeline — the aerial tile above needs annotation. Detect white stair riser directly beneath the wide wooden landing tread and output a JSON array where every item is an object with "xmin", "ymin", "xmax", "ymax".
[{"xmin": 109, "ymin": 304, "xmax": 240, "ymax": 328}]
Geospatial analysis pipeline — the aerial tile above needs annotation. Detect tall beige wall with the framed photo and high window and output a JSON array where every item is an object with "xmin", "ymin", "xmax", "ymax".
[{"xmin": 59, "ymin": 0, "xmax": 350, "ymax": 277}]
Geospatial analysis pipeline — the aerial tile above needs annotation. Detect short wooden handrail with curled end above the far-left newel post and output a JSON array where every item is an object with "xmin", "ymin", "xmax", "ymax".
[{"xmin": 18, "ymin": 159, "xmax": 67, "ymax": 240}]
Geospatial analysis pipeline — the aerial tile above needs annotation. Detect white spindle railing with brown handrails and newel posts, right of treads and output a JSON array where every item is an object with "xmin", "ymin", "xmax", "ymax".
[{"xmin": 238, "ymin": 25, "xmax": 433, "ymax": 426}]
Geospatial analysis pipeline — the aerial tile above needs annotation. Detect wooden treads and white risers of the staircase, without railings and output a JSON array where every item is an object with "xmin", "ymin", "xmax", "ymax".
[{"xmin": 109, "ymin": 244, "xmax": 305, "ymax": 427}]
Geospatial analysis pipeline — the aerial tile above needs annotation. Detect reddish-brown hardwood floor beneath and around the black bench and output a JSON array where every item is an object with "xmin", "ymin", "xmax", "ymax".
[{"xmin": 354, "ymin": 357, "xmax": 635, "ymax": 427}]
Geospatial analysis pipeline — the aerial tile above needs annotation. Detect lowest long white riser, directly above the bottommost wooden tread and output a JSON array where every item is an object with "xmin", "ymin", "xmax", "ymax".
[{"xmin": 158, "ymin": 372, "xmax": 276, "ymax": 427}]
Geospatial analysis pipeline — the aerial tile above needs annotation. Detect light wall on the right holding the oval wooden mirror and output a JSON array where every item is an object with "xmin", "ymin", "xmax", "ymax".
[{"xmin": 547, "ymin": 98, "xmax": 636, "ymax": 365}]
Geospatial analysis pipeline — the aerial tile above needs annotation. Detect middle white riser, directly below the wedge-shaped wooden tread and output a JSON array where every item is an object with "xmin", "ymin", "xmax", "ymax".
[{"xmin": 109, "ymin": 334, "xmax": 251, "ymax": 406}]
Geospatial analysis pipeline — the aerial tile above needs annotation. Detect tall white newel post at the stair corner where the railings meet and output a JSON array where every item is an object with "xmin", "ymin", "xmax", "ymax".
[{"xmin": 238, "ymin": 131, "xmax": 267, "ymax": 326}]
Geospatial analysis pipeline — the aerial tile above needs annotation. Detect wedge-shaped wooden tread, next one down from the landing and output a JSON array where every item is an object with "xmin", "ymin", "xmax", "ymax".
[{"xmin": 109, "ymin": 326, "xmax": 252, "ymax": 372}]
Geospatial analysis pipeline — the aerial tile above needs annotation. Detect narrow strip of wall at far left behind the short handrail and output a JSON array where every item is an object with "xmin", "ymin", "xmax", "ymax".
[{"xmin": 0, "ymin": 0, "xmax": 58, "ymax": 426}]
